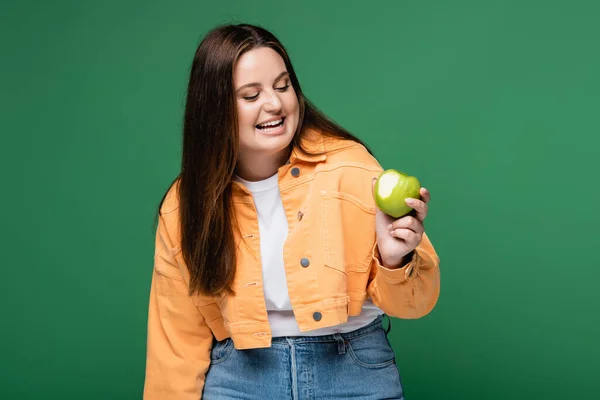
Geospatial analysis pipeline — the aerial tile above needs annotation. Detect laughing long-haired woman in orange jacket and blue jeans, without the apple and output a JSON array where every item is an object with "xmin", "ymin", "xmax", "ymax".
[{"xmin": 144, "ymin": 25, "xmax": 439, "ymax": 400}]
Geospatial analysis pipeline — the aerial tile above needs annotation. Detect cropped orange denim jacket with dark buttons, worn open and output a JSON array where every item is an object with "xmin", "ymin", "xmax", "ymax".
[{"xmin": 144, "ymin": 132, "xmax": 440, "ymax": 400}]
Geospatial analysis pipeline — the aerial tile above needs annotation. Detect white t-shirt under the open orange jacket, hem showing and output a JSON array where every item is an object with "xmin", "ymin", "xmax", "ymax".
[{"xmin": 234, "ymin": 174, "xmax": 383, "ymax": 337}]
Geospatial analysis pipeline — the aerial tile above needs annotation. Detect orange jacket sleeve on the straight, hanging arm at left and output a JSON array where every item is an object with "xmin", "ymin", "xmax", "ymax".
[{"xmin": 144, "ymin": 216, "xmax": 213, "ymax": 400}]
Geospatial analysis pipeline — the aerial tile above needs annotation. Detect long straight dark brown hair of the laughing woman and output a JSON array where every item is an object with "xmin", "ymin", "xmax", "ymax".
[{"xmin": 152, "ymin": 24, "xmax": 371, "ymax": 296}]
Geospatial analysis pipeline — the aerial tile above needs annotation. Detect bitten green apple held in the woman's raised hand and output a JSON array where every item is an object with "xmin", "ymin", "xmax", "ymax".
[{"xmin": 374, "ymin": 169, "xmax": 421, "ymax": 218}]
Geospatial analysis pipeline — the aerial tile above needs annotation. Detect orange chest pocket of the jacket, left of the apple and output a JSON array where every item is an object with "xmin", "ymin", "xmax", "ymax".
[{"xmin": 321, "ymin": 190, "xmax": 377, "ymax": 273}]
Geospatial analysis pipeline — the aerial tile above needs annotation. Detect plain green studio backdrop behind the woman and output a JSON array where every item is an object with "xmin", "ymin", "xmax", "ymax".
[{"xmin": 0, "ymin": 0, "xmax": 600, "ymax": 400}]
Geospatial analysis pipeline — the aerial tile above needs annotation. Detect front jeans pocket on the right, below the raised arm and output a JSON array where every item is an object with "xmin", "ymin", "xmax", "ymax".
[{"xmin": 347, "ymin": 328, "xmax": 396, "ymax": 368}]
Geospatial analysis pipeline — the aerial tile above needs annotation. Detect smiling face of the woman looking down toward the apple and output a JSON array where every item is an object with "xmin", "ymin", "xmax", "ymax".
[{"xmin": 233, "ymin": 47, "xmax": 299, "ymax": 162}]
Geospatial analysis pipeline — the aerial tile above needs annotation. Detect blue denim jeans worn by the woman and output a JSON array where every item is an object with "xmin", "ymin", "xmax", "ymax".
[{"xmin": 202, "ymin": 316, "xmax": 404, "ymax": 400}]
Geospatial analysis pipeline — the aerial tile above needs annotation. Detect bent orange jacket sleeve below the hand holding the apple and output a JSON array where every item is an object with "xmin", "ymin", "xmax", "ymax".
[{"xmin": 367, "ymin": 233, "xmax": 440, "ymax": 319}]
